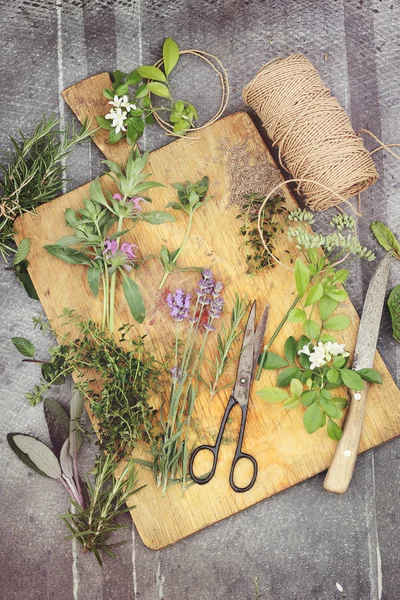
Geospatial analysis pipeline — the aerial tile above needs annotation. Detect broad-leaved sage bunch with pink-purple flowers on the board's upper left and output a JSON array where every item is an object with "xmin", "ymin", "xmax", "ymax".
[{"xmin": 45, "ymin": 151, "xmax": 175, "ymax": 332}]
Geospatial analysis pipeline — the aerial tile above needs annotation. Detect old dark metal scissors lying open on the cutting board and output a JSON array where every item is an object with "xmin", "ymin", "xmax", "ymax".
[{"xmin": 189, "ymin": 301, "xmax": 269, "ymax": 492}]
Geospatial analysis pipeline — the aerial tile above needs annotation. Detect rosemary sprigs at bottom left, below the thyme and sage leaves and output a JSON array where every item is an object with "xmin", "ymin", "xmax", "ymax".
[{"xmin": 60, "ymin": 454, "xmax": 142, "ymax": 565}]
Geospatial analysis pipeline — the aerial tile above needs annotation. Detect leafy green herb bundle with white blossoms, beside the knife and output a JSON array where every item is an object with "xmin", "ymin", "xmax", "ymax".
[{"xmin": 257, "ymin": 209, "xmax": 382, "ymax": 440}]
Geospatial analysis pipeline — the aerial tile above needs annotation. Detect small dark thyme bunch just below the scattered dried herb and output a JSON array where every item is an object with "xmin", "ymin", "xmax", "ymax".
[{"xmin": 237, "ymin": 194, "xmax": 287, "ymax": 273}]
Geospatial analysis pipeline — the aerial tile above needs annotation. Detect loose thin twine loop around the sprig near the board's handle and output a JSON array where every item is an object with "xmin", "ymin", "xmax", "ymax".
[{"xmin": 153, "ymin": 49, "xmax": 229, "ymax": 137}]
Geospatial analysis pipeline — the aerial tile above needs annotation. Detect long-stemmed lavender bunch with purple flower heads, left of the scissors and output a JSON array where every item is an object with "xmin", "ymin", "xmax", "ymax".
[{"xmin": 150, "ymin": 269, "xmax": 224, "ymax": 494}]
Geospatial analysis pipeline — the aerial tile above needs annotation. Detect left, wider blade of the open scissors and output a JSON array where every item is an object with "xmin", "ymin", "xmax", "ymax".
[{"xmin": 233, "ymin": 301, "xmax": 256, "ymax": 406}]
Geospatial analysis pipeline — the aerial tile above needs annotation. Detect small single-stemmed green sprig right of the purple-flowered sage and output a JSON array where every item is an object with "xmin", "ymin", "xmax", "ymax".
[{"xmin": 159, "ymin": 176, "xmax": 210, "ymax": 290}]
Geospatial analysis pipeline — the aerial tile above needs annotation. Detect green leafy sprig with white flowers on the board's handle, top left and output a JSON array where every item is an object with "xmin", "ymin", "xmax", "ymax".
[{"xmin": 97, "ymin": 37, "xmax": 198, "ymax": 145}]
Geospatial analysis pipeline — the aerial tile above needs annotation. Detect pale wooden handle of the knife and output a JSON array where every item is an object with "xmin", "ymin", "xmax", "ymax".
[{"xmin": 324, "ymin": 381, "xmax": 368, "ymax": 494}]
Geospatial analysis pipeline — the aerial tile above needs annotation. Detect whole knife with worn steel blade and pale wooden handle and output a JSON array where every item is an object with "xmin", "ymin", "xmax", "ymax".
[{"xmin": 324, "ymin": 252, "xmax": 392, "ymax": 494}]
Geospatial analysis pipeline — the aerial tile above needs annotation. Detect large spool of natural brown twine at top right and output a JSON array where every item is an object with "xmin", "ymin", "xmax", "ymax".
[{"xmin": 243, "ymin": 54, "xmax": 378, "ymax": 211}]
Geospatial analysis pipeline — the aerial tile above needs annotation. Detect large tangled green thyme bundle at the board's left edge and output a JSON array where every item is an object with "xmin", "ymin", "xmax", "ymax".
[{"xmin": 13, "ymin": 310, "xmax": 164, "ymax": 457}]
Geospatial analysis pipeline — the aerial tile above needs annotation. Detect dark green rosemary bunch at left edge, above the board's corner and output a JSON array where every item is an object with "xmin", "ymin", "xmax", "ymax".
[{"xmin": 0, "ymin": 116, "xmax": 93, "ymax": 259}]
